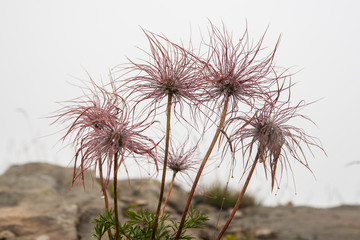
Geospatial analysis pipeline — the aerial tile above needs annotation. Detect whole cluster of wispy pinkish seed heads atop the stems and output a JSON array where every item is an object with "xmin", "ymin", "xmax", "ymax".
[{"xmin": 52, "ymin": 24, "xmax": 322, "ymax": 193}]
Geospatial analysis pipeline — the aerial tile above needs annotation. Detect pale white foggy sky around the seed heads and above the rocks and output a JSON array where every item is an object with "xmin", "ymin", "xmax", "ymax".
[{"xmin": 0, "ymin": 0, "xmax": 360, "ymax": 207}]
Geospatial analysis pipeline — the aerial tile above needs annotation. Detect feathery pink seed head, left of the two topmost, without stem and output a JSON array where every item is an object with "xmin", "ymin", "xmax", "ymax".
[{"xmin": 116, "ymin": 31, "xmax": 202, "ymax": 120}]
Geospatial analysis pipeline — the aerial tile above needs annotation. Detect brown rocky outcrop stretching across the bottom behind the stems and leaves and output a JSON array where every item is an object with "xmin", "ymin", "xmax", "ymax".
[{"xmin": 0, "ymin": 163, "xmax": 360, "ymax": 240}]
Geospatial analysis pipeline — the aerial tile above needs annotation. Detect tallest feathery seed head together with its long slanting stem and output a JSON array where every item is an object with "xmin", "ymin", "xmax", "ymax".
[{"xmin": 176, "ymin": 24, "xmax": 285, "ymax": 239}]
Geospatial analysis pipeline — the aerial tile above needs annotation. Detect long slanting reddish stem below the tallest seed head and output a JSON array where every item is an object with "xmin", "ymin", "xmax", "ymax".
[{"xmin": 175, "ymin": 98, "xmax": 229, "ymax": 240}]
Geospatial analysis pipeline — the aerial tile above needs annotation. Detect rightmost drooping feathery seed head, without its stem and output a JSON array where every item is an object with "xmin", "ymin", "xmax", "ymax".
[{"xmin": 231, "ymin": 100, "xmax": 324, "ymax": 189}]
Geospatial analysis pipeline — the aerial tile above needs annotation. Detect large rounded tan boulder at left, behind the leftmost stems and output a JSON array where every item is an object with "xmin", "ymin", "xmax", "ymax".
[{"xmin": 0, "ymin": 163, "xmax": 104, "ymax": 240}]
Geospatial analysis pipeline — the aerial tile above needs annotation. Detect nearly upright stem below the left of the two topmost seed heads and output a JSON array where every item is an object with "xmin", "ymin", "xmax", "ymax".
[{"xmin": 151, "ymin": 93, "xmax": 173, "ymax": 240}]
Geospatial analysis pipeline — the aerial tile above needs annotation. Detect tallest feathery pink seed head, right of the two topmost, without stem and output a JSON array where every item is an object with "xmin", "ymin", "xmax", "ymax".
[{"xmin": 202, "ymin": 24, "xmax": 285, "ymax": 113}]
